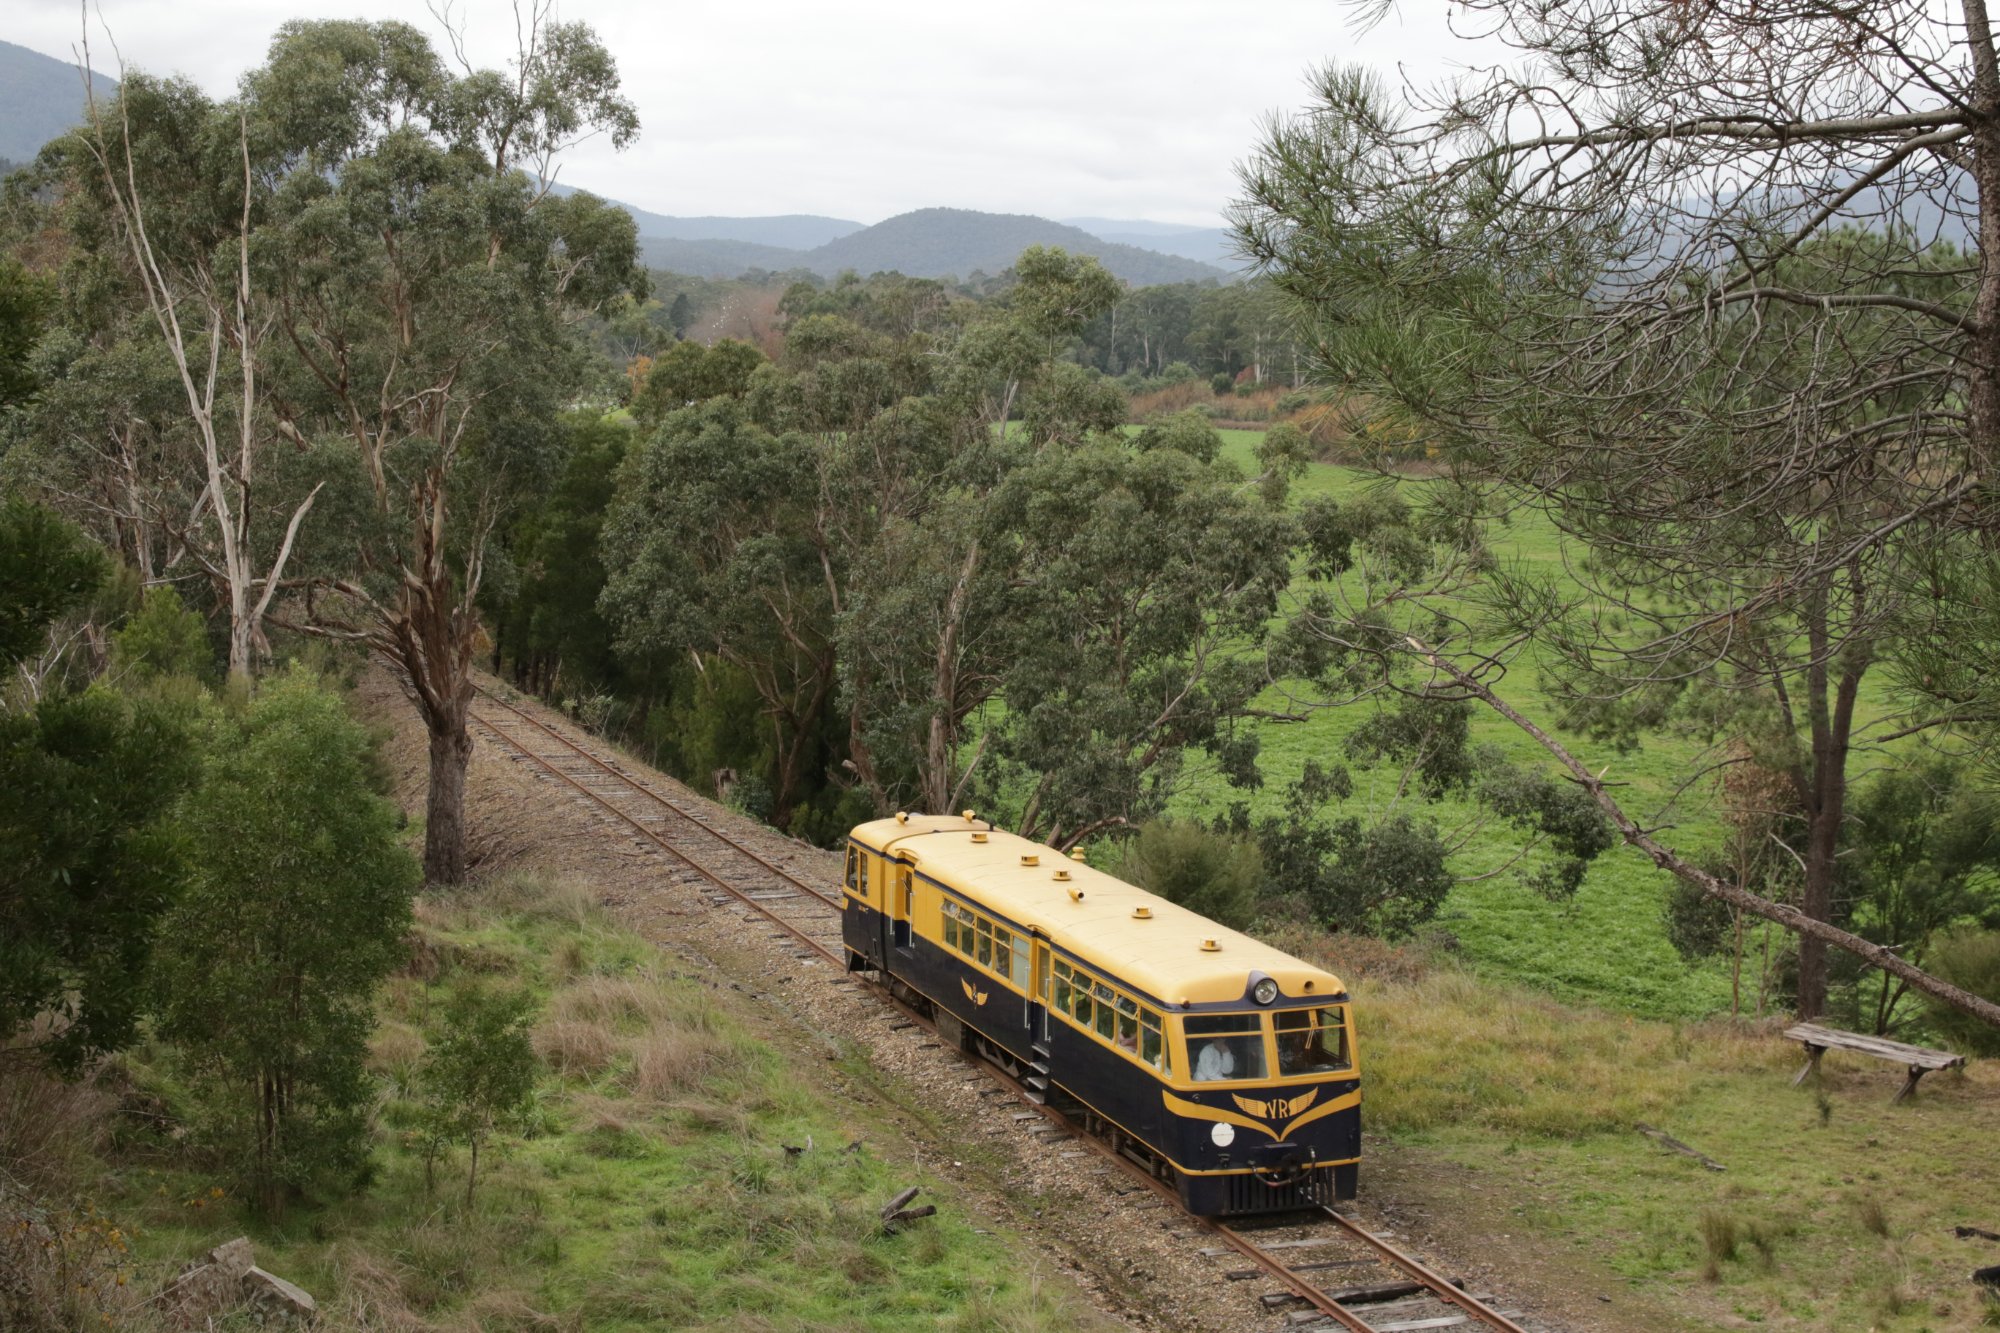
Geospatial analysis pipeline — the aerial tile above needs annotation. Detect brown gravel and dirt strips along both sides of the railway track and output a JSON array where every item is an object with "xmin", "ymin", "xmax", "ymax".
[{"xmin": 358, "ymin": 671, "xmax": 1640, "ymax": 1333}]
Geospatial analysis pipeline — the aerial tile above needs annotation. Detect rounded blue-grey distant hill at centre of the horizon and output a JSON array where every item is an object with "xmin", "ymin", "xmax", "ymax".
[{"xmin": 806, "ymin": 208, "xmax": 1228, "ymax": 286}]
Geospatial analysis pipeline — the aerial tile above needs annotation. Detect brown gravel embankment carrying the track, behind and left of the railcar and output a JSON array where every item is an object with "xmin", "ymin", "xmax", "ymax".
[{"xmin": 410, "ymin": 689, "xmax": 1596, "ymax": 1329}]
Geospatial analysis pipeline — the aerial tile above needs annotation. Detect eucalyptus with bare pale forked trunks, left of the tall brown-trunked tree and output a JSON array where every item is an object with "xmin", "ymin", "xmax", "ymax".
[{"xmin": 32, "ymin": 70, "xmax": 318, "ymax": 677}]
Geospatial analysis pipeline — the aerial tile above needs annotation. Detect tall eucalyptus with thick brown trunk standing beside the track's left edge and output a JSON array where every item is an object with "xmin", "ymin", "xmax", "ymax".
[{"xmin": 244, "ymin": 20, "xmax": 640, "ymax": 883}]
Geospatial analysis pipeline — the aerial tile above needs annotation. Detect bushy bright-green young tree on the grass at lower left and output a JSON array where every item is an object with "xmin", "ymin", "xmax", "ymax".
[{"xmin": 154, "ymin": 675, "xmax": 418, "ymax": 1215}]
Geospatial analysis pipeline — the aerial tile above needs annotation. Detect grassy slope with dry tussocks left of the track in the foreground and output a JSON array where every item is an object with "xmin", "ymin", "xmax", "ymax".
[{"xmin": 31, "ymin": 877, "xmax": 1120, "ymax": 1331}]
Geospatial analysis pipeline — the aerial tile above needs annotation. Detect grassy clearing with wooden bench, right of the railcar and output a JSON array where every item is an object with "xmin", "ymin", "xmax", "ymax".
[{"xmin": 1274, "ymin": 929, "xmax": 2000, "ymax": 1333}]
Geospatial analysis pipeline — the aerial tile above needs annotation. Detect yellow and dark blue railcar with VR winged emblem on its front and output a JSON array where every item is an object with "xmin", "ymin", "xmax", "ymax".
[{"xmin": 842, "ymin": 811, "xmax": 1362, "ymax": 1217}]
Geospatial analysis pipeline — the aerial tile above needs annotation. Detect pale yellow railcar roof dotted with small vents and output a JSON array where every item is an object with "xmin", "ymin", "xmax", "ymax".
[{"xmin": 854, "ymin": 815, "xmax": 1346, "ymax": 1005}]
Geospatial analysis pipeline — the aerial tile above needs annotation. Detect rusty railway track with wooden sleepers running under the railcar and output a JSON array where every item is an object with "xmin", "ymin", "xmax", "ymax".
[{"xmin": 472, "ymin": 687, "xmax": 1532, "ymax": 1333}]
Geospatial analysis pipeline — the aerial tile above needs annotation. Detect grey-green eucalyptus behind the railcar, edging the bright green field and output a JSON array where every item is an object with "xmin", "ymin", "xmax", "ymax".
[{"xmin": 992, "ymin": 418, "xmax": 1298, "ymax": 847}]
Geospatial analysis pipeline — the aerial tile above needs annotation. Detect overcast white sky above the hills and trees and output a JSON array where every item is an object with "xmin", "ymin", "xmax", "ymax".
[{"xmin": 11, "ymin": 0, "xmax": 1488, "ymax": 226}]
